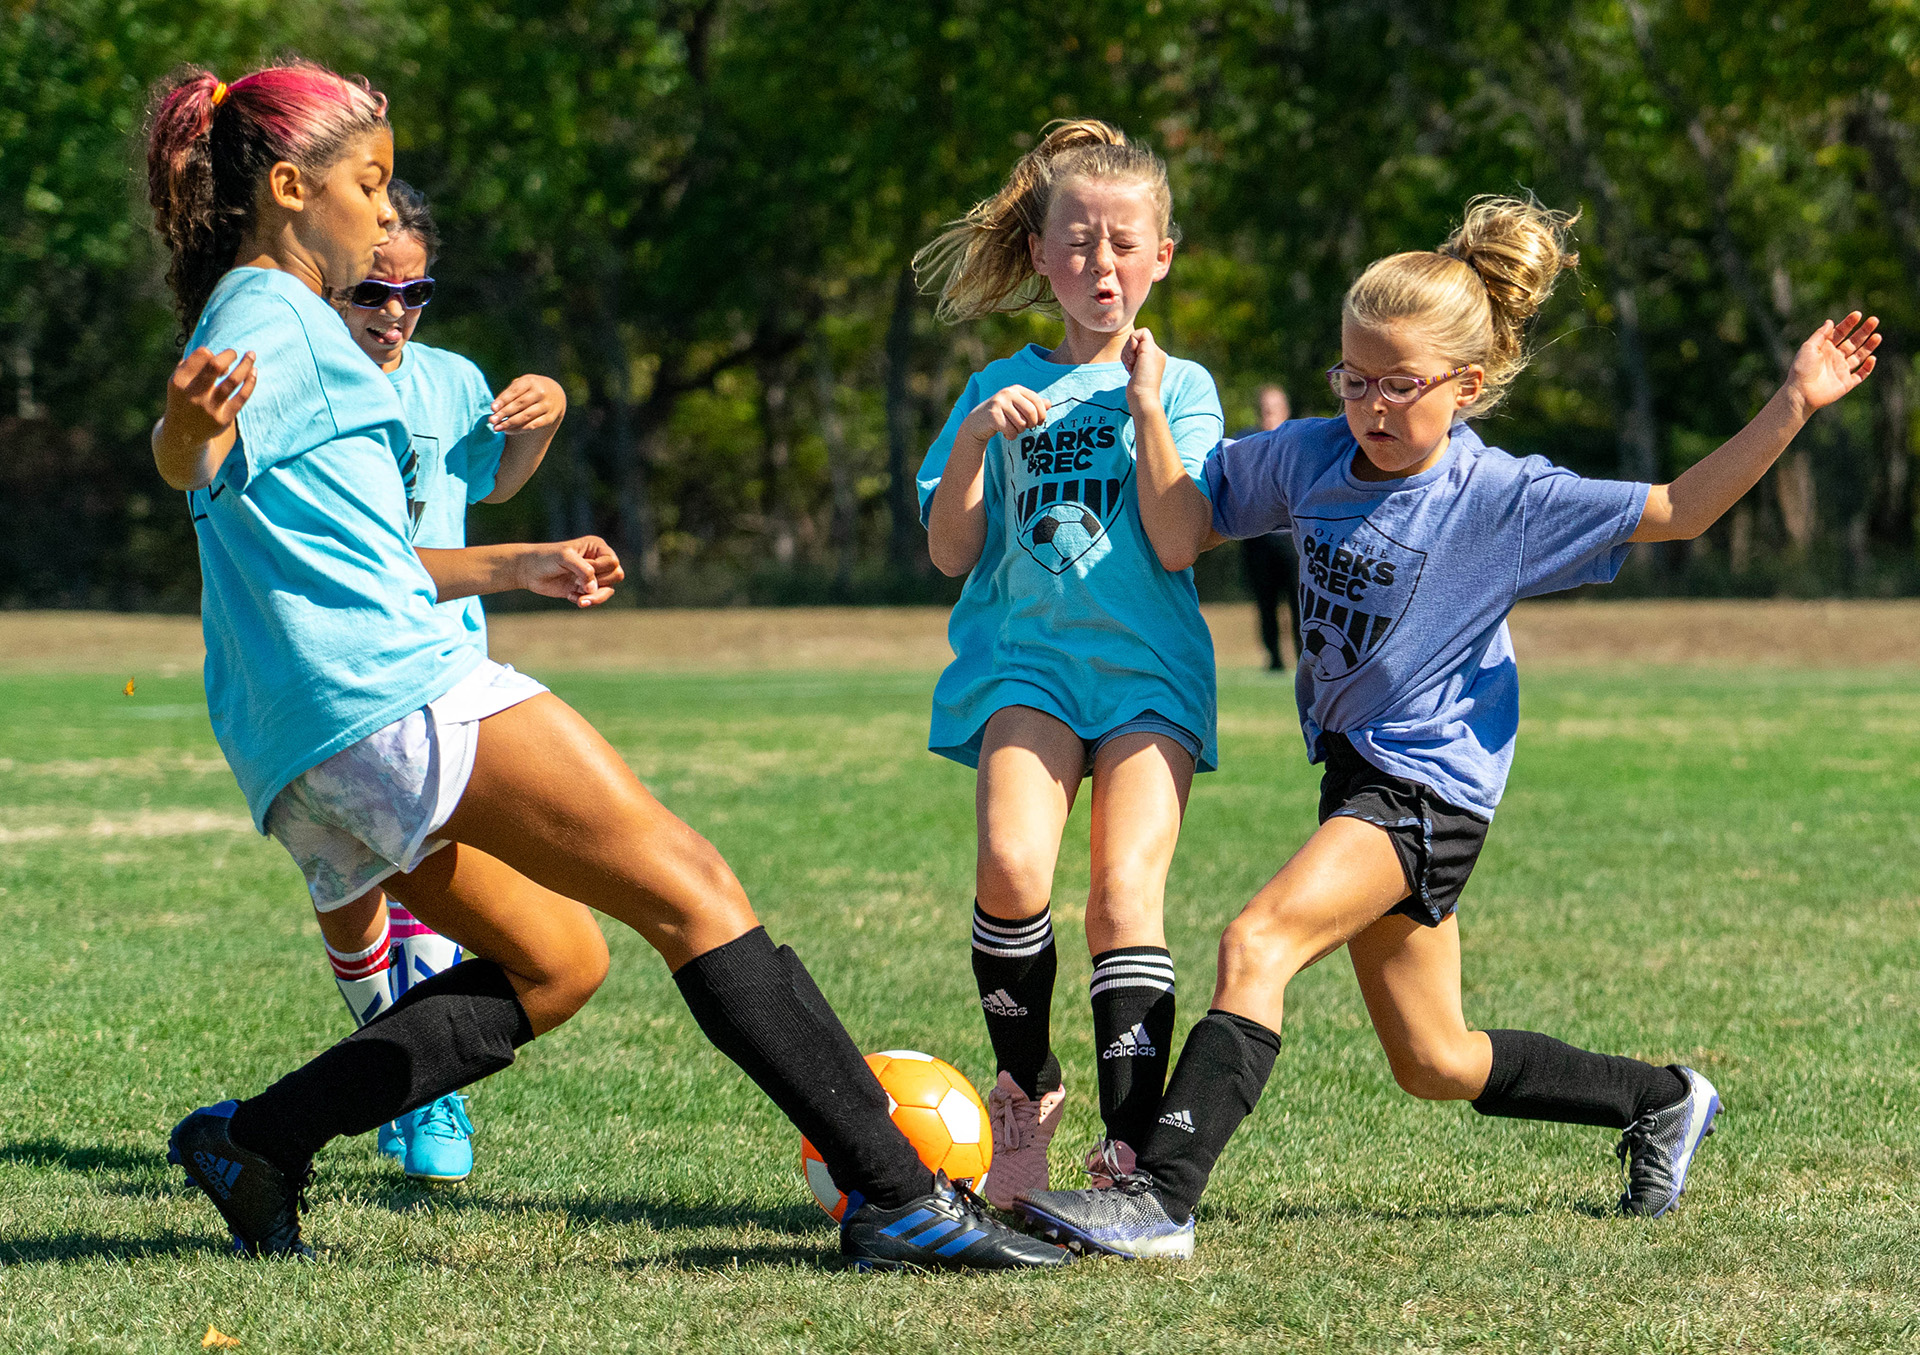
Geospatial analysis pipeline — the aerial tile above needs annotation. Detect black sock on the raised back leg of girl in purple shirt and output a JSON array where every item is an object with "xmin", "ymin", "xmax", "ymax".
[{"xmin": 1473, "ymin": 1031, "xmax": 1688, "ymax": 1129}]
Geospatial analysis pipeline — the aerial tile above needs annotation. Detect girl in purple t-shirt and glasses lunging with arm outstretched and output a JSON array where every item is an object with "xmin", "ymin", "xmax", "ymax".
[{"xmin": 1023, "ymin": 198, "xmax": 1880, "ymax": 1255}]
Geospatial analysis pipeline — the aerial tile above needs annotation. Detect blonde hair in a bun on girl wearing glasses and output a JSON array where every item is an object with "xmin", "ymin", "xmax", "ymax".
[{"xmin": 1342, "ymin": 194, "xmax": 1580, "ymax": 418}]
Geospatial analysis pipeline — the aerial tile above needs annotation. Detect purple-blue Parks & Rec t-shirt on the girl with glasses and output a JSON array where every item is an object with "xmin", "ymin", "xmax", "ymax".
[{"xmin": 1206, "ymin": 418, "xmax": 1647, "ymax": 818}]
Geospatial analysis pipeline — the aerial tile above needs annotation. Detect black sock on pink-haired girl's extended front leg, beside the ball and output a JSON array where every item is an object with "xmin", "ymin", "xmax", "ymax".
[{"xmin": 674, "ymin": 927, "xmax": 933, "ymax": 1209}]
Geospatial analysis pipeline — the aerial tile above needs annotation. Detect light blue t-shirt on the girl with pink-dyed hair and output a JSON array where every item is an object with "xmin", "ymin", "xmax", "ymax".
[{"xmin": 186, "ymin": 269, "xmax": 482, "ymax": 831}]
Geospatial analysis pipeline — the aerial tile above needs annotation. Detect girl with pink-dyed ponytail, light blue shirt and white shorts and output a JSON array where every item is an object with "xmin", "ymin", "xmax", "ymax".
[{"xmin": 148, "ymin": 63, "xmax": 1068, "ymax": 1269}]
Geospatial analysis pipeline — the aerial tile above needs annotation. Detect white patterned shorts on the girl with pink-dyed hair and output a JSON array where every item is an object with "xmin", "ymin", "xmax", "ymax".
[{"xmin": 267, "ymin": 658, "xmax": 545, "ymax": 914}]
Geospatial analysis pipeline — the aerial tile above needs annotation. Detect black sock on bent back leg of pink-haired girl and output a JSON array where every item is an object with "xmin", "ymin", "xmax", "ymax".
[{"xmin": 228, "ymin": 960, "xmax": 534, "ymax": 1175}]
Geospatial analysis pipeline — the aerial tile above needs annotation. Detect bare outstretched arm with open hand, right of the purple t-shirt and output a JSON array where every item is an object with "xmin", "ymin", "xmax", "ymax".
[{"xmin": 1628, "ymin": 311, "xmax": 1880, "ymax": 541}]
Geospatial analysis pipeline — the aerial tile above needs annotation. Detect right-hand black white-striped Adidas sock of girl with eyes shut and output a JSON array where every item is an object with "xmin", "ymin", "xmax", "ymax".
[{"xmin": 1087, "ymin": 946, "xmax": 1173, "ymax": 1153}]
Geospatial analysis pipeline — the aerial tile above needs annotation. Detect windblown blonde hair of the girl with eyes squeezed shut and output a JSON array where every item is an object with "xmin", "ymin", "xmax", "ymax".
[{"xmin": 914, "ymin": 117, "xmax": 1179, "ymax": 322}]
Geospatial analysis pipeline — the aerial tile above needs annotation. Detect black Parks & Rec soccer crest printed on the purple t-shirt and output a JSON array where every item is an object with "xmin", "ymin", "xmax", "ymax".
[{"xmin": 1294, "ymin": 518, "xmax": 1427, "ymax": 681}]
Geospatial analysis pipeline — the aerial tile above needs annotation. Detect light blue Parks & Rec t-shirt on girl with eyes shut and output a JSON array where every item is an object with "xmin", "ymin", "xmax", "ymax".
[{"xmin": 920, "ymin": 344, "xmax": 1225, "ymax": 772}]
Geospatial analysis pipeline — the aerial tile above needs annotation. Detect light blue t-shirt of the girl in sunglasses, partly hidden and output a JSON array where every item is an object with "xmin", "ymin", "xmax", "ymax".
[{"xmin": 386, "ymin": 342, "xmax": 507, "ymax": 654}]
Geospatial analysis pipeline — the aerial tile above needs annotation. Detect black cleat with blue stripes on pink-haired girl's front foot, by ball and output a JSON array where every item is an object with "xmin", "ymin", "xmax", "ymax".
[{"xmin": 841, "ymin": 1171, "xmax": 1073, "ymax": 1271}]
